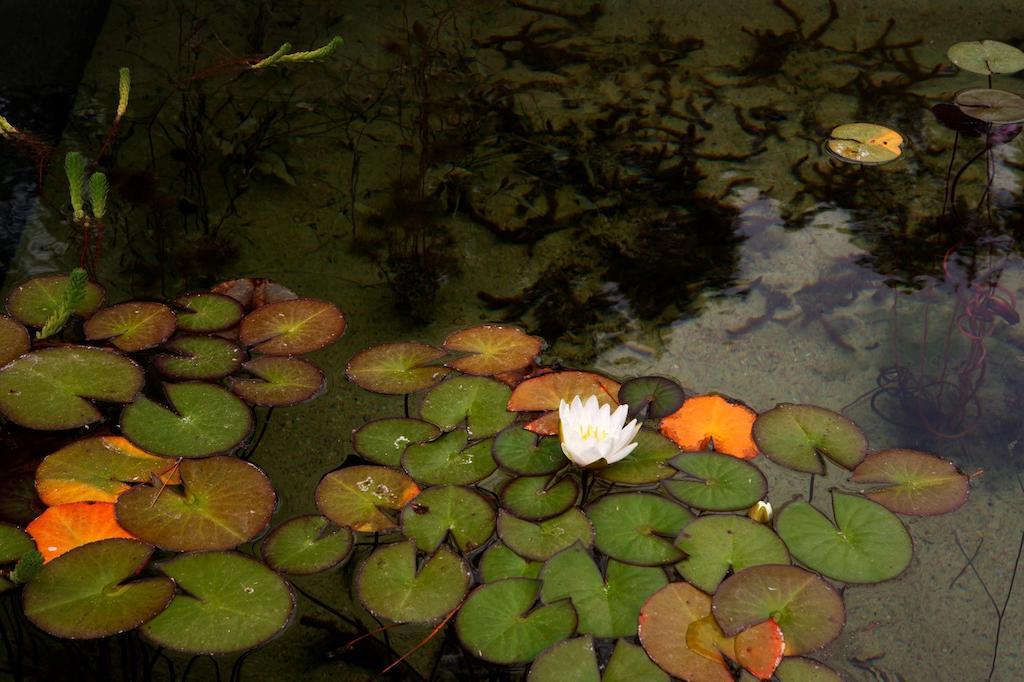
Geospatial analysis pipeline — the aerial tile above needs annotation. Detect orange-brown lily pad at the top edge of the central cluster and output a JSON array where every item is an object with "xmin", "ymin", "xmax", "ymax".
[{"xmin": 444, "ymin": 325, "xmax": 544, "ymax": 377}]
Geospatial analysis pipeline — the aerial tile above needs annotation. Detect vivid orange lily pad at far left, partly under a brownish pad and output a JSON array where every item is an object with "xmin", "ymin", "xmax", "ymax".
[{"xmin": 25, "ymin": 502, "xmax": 135, "ymax": 561}]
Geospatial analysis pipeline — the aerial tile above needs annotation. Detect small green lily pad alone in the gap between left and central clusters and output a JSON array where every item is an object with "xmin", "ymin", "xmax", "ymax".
[{"xmin": 260, "ymin": 514, "xmax": 354, "ymax": 576}]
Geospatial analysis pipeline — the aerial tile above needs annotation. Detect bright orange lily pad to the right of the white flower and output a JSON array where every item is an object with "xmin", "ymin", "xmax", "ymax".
[{"xmin": 662, "ymin": 393, "xmax": 758, "ymax": 460}]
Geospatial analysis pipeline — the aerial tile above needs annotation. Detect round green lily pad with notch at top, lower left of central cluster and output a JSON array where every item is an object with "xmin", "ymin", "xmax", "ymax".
[{"xmin": 354, "ymin": 541, "xmax": 471, "ymax": 623}]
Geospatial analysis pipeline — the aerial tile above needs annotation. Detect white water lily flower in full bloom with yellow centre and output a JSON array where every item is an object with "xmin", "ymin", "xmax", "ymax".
[{"xmin": 558, "ymin": 395, "xmax": 640, "ymax": 467}]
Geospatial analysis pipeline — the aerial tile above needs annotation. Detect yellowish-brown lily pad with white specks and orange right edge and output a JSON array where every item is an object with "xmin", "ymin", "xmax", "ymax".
[{"xmin": 316, "ymin": 465, "xmax": 420, "ymax": 532}]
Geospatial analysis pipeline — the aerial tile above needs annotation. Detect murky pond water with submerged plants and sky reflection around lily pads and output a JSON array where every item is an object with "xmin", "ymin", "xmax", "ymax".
[{"xmin": 0, "ymin": 0, "xmax": 1024, "ymax": 680}]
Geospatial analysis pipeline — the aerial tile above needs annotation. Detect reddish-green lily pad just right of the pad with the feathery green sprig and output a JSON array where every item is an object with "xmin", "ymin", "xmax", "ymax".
[{"xmin": 84, "ymin": 301, "xmax": 177, "ymax": 353}]
